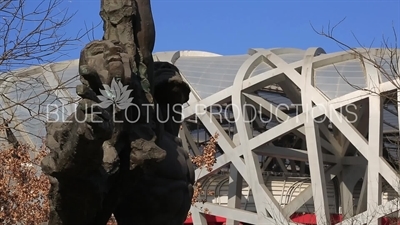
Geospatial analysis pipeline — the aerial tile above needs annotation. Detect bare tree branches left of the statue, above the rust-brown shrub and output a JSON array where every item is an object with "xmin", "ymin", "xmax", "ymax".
[{"xmin": 0, "ymin": 0, "xmax": 92, "ymax": 146}]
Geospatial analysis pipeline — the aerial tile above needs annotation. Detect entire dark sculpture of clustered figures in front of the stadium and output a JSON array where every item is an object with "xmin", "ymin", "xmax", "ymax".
[{"xmin": 42, "ymin": 0, "xmax": 194, "ymax": 225}]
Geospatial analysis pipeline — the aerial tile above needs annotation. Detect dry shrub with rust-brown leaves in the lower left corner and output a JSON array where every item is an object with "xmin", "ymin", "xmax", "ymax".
[{"xmin": 0, "ymin": 145, "xmax": 50, "ymax": 225}]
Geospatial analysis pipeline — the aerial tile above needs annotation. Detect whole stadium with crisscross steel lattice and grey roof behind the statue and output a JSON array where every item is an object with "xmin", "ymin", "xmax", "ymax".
[{"xmin": 0, "ymin": 48, "xmax": 400, "ymax": 225}]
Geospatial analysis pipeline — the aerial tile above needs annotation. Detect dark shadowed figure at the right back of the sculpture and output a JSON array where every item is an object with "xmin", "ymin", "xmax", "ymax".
[{"xmin": 115, "ymin": 62, "xmax": 194, "ymax": 225}]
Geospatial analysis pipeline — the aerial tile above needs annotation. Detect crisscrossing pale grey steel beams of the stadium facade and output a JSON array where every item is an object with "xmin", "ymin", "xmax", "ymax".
[{"xmin": 162, "ymin": 48, "xmax": 400, "ymax": 225}]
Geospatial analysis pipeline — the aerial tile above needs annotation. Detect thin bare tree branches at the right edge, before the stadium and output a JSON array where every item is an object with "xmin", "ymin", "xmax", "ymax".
[{"xmin": 312, "ymin": 18, "xmax": 400, "ymax": 224}]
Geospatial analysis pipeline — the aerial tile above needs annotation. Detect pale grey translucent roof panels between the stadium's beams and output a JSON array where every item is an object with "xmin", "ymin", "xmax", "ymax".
[{"xmin": 0, "ymin": 48, "xmax": 399, "ymax": 148}]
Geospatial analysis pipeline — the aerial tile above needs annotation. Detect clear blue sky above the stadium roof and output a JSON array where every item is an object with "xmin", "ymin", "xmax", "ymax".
[{"xmin": 54, "ymin": 0, "xmax": 400, "ymax": 59}]
